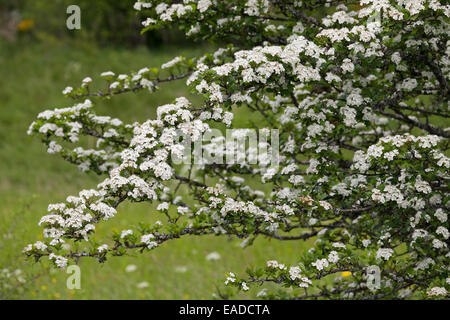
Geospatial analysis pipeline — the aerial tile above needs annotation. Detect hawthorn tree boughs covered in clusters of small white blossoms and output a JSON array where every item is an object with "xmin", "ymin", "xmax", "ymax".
[{"xmin": 25, "ymin": 0, "xmax": 450, "ymax": 299}]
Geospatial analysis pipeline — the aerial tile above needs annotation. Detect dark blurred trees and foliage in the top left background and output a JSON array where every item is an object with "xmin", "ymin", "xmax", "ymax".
[{"xmin": 0, "ymin": 0, "xmax": 187, "ymax": 47}]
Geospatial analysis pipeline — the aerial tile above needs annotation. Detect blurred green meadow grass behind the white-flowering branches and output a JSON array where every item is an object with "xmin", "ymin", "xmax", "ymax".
[{"xmin": 0, "ymin": 43, "xmax": 305, "ymax": 299}]
